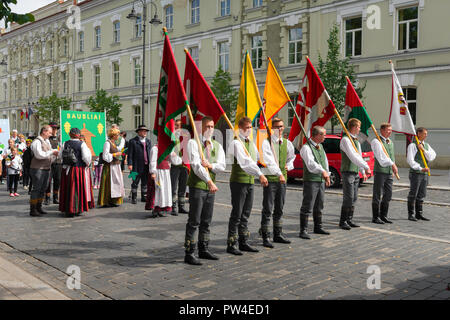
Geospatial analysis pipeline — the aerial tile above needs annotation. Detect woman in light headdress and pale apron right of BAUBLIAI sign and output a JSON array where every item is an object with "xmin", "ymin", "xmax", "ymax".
[{"xmin": 98, "ymin": 129, "xmax": 125, "ymax": 207}]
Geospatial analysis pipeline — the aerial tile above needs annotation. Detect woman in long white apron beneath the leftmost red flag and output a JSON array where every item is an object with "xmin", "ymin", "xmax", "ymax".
[{"xmin": 145, "ymin": 145, "xmax": 181, "ymax": 218}]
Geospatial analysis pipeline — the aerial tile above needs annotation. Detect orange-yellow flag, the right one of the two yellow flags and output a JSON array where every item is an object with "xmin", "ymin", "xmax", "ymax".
[{"xmin": 264, "ymin": 58, "xmax": 291, "ymax": 125}]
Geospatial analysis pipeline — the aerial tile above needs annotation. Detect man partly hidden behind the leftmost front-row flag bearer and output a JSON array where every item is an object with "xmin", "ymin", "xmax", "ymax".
[{"xmin": 170, "ymin": 119, "xmax": 188, "ymax": 216}]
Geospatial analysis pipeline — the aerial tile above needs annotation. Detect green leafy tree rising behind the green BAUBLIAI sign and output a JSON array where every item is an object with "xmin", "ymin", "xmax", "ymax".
[{"xmin": 86, "ymin": 89, "xmax": 123, "ymax": 125}]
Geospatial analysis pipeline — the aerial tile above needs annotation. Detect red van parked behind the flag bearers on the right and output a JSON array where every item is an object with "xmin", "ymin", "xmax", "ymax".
[{"xmin": 288, "ymin": 135, "xmax": 375, "ymax": 187}]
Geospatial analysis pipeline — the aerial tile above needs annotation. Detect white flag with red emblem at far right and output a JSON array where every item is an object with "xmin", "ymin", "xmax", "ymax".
[{"xmin": 389, "ymin": 62, "xmax": 416, "ymax": 136}]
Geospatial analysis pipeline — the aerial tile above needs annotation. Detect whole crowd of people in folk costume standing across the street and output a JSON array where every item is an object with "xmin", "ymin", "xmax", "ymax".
[{"xmin": 0, "ymin": 116, "xmax": 436, "ymax": 265}]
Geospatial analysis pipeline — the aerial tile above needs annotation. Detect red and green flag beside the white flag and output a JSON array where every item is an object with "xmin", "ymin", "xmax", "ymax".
[{"xmin": 344, "ymin": 78, "xmax": 372, "ymax": 141}]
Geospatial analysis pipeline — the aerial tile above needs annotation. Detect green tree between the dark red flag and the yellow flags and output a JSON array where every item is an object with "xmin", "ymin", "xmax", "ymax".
[{"xmin": 211, "ymin": 65, "xmax": 239, "ymax": 123}]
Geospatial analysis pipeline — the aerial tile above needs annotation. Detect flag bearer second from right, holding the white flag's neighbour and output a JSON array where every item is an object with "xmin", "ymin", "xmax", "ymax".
[{"xmin": 370, "ymin": 123, "xmax": 398, "ymax": 224}]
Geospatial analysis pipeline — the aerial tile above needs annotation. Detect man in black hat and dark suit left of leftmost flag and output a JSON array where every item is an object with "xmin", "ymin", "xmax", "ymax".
[{"xmin": 128, "ymin": 125, "xmax": 152, "ymax": 204}]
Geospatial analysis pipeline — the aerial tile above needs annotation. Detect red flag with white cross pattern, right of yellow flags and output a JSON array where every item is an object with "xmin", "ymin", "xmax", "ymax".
[{"xmin": 289, "ymin": 58, "xmax": 335, "ymax": 146}]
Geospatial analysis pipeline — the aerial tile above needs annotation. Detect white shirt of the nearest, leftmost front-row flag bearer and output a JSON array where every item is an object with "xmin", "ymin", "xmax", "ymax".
[{"xmin": 187, "ymin": 136, "xmax": 226, "ymax": 182}]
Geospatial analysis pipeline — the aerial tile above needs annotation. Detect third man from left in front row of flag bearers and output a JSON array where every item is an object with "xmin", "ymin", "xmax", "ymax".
[{"xmin": 260, "ymin": 118, "xmax": 295, "ymax": 248}]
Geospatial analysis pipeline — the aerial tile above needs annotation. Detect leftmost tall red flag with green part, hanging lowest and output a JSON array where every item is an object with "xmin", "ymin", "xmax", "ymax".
[{"xmin": 153, "ymin": 28, "xmax": 188, "ymax": 163}]
